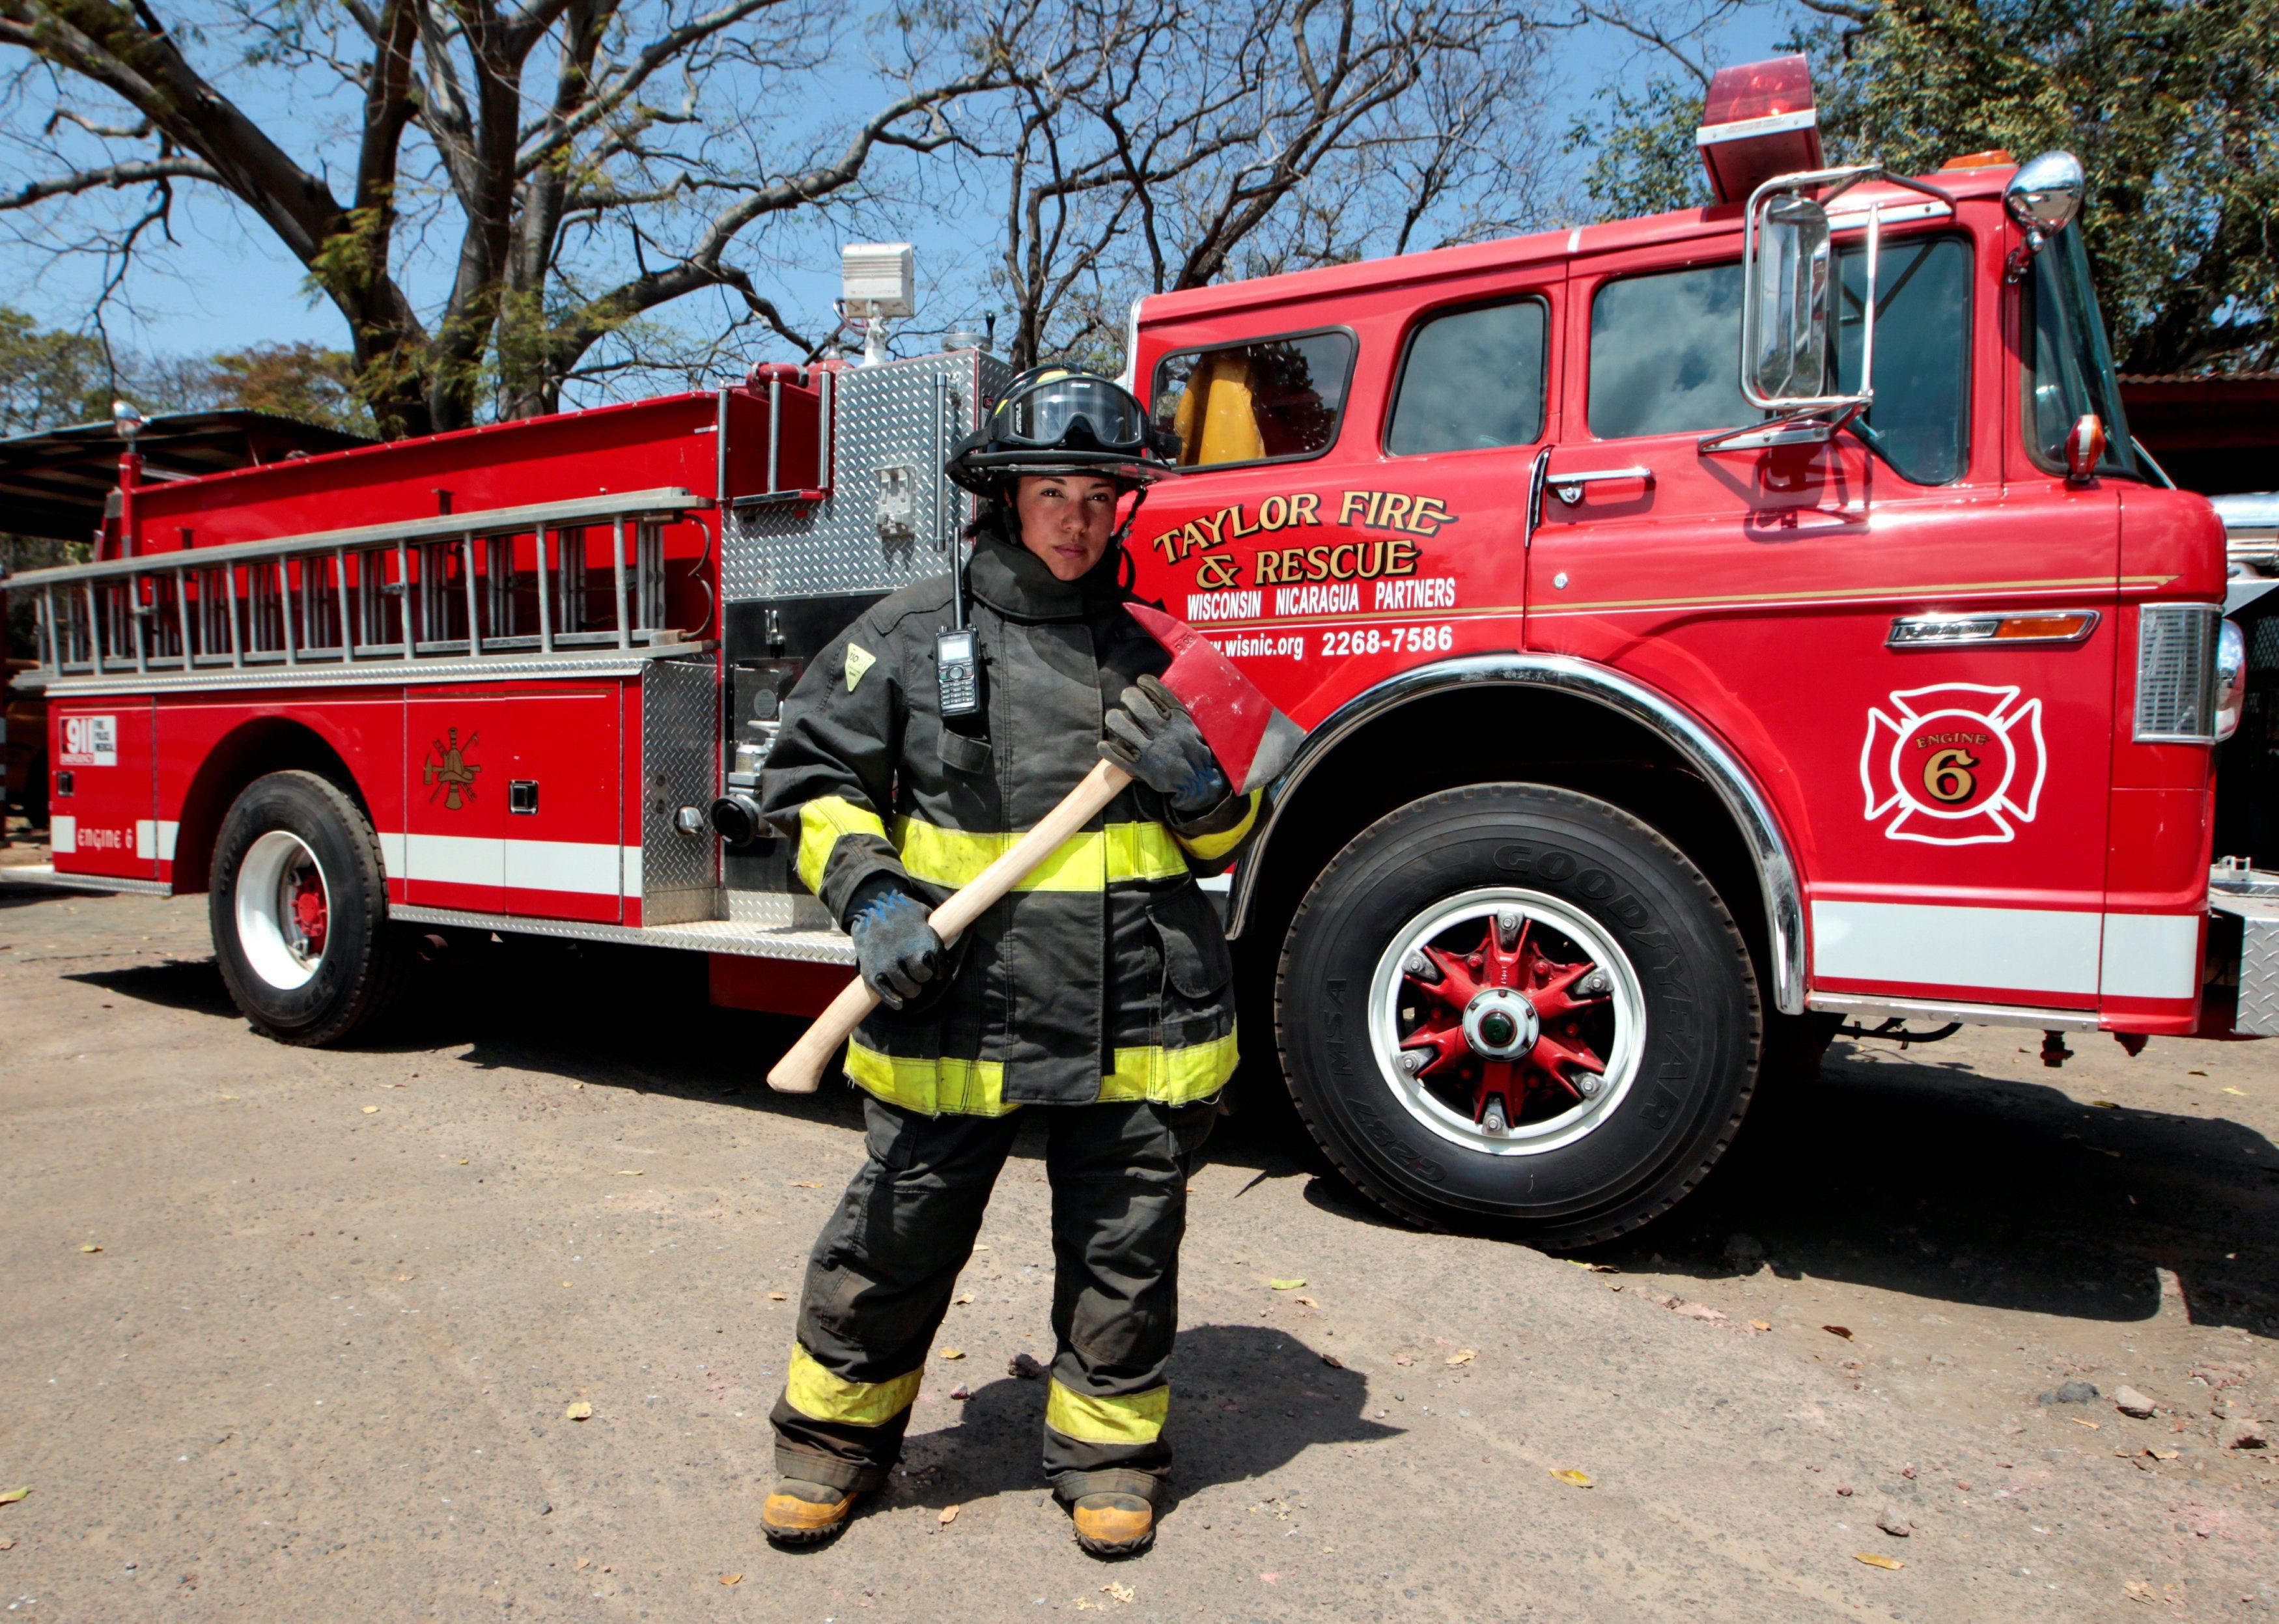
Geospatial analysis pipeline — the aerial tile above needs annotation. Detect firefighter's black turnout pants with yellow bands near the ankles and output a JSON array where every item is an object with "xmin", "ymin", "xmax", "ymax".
[{"xmin": 770, "ymin": 1098, "xmax": 1220, "ymax": 1501}]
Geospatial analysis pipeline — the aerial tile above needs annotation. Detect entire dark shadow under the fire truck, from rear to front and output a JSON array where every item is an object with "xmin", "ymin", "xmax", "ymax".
[{"xmin": 76, "ymin": 911, "xmax": 2279, "ymax": 1335}]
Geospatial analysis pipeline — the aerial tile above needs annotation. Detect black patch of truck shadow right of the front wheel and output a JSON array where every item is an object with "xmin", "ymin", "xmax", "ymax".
[{"xmin": 1593, "ymin": 1043, "xmax": 2279, "ymax": 1337}]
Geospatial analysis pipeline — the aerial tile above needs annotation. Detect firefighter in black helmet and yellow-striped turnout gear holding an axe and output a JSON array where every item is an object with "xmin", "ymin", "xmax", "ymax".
[{"xmin": 761, "ymin": 369, "xmax": 1258, "ymax": 1556}]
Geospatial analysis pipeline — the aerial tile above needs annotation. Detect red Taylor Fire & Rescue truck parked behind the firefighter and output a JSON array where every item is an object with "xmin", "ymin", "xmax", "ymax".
[{"xmin": 14, "ymin": 59, "xmax": 2243, "ymax": 1244}]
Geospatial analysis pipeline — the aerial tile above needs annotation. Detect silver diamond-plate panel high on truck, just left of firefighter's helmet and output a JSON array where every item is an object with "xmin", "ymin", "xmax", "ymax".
[{"xmin": 720, "ymin": 353, "xmax": 1012, "ymax": 604}]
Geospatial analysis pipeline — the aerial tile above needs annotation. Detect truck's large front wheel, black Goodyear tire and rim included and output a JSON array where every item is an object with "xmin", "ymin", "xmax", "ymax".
[{"xmin": 1276, "ymin": 783, "xmax": 1762, "ymax": 1248}]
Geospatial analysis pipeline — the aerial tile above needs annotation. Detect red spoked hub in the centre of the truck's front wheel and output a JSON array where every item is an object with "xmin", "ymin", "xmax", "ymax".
[{"xmin": 1402, "ymin": 916, "xmax": 1609, "ymax": 1125}]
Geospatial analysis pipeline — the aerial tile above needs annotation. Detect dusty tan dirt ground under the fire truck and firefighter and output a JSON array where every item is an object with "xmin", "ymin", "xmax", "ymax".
[{"xmin": 13, "ymin": 854, "xmax": 2279, "ymax": 1624}]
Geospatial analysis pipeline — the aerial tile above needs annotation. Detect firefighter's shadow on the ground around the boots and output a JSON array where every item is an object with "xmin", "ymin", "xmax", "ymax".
[{"xmin": 891, "ymin": 1326, "xmax": 1402, "ymax": 1505}]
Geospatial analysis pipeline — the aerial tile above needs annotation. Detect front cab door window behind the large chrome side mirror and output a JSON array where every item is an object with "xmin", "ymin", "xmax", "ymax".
[{"xmin": 1589, "ymin": 237, "xmax": 1972, "ymax": 485}]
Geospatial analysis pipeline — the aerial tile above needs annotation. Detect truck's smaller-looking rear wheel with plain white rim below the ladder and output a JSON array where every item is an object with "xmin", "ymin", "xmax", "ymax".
[{"xmin": 208, "ymin": 772, "xmax": 413, "ymax": 1043}]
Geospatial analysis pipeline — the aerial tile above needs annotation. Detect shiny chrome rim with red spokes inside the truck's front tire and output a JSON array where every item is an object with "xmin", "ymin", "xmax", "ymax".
[{"xmin": 1370, "ymin": 886, "xmax": 1645, "ymax": 1155}]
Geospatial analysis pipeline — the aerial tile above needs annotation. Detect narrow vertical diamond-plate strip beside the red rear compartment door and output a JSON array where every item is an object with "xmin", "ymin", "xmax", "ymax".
[{"xmin": 641, "ymin": 660, "xmax": 720, "ymax": 925}]
